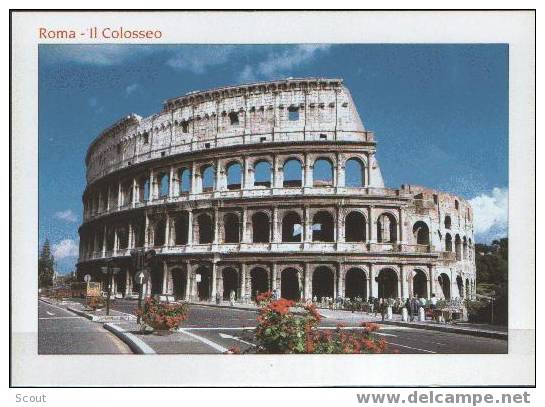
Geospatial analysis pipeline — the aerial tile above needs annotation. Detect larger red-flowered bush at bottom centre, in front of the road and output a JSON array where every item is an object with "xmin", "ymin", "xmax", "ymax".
[{"xmin": 255, "ymin": 292, "xmax": 387, "ymax": 353}]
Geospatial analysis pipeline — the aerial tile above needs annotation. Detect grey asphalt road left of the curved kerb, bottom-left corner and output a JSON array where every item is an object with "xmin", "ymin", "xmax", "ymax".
[{"xmin": 38, "ymin": 301, "xmax": 132, "ymax": 355}]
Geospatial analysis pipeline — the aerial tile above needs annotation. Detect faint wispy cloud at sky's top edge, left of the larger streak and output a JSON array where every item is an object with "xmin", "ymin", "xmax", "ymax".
[{"xmin": 167, "ymin": 45, "xmax": 235, "ymax": 74}]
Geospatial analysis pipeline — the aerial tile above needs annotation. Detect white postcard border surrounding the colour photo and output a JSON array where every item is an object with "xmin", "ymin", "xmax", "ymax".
[{"xmin": 11, "ymin": 11, "xmax": 535, "ymax": 386}]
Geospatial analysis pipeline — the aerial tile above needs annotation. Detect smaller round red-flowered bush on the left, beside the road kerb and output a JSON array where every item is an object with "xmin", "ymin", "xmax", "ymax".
[{"xmin": 138, "ymin": 297, "xmax": 188, "ymax": 331}]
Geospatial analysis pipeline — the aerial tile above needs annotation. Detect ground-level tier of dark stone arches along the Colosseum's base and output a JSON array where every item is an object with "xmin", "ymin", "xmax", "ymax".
[{"xmin": 78, "ymin": 258, "xmax": 476, "ymax": 302}]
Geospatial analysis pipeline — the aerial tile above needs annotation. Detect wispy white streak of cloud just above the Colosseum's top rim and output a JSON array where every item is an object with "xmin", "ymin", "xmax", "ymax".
[{"xmin": 239, "ymin": 44, "xmax": 331, "ymax": 82}]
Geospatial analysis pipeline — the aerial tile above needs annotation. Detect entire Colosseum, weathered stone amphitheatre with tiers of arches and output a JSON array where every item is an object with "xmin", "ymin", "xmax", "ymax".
[{"xmin": 77, "ymin": 78, "xmax": 476, "ymax": 301}]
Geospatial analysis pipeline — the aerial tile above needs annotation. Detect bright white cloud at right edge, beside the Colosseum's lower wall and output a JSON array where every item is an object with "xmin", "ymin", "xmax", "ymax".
[{"xmin": 469, "ymin": 188, "xmax": 508, "ymax": 240}]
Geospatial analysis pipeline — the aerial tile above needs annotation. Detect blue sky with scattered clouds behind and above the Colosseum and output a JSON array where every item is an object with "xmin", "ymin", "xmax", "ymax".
[{"xmin": 39, "ymin": 44, "xmax": 508, "ymax": 272}]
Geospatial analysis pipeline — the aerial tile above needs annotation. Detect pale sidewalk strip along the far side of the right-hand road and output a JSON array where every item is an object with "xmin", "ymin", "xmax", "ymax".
[{"xmin": 318, "ymin": 309, "xmax": 508, "ymax": 339}]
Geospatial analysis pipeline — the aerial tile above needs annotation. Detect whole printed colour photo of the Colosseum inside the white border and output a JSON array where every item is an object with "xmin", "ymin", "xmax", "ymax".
[{"xmin": 39, "ymin": 44, "xmax": 507, "ymax": 354}]
